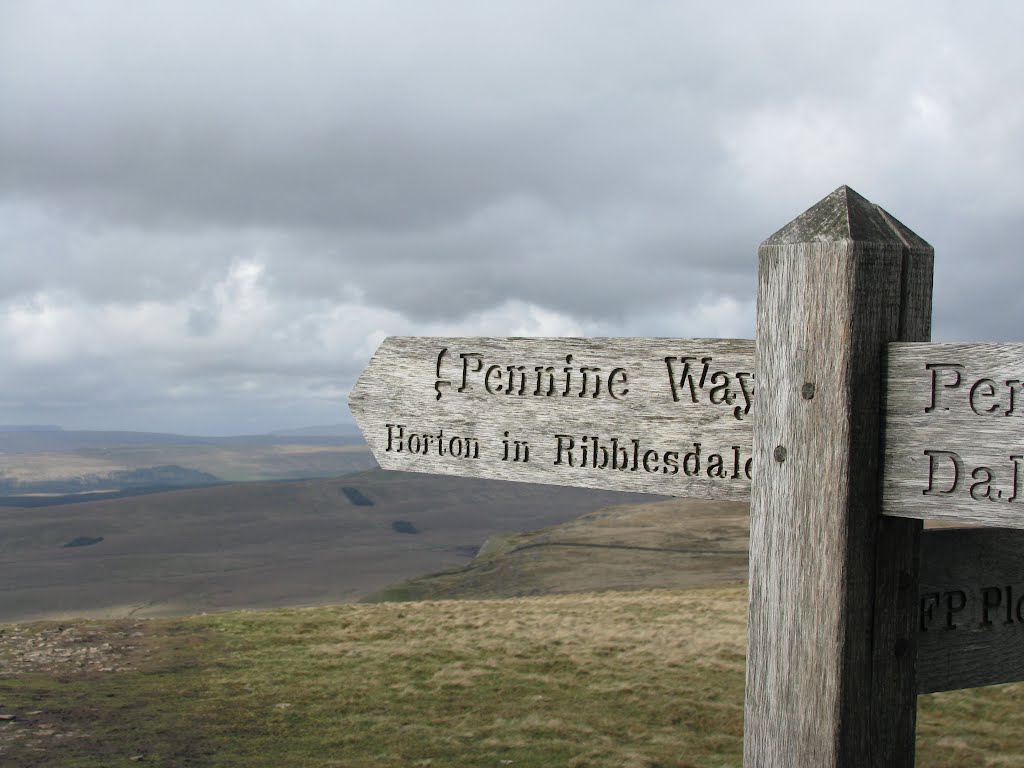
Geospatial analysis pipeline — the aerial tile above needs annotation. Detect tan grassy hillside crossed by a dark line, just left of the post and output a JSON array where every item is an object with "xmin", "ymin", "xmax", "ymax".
[{"xmin": 365, "ymin": 499, "xmax": 750, "ymax": 602}]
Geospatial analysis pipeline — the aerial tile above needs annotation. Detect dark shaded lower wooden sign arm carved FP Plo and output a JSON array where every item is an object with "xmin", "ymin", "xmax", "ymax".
[{"xmin": 915, "ymin": 528, "xmax": 1024, "ymax": 693}]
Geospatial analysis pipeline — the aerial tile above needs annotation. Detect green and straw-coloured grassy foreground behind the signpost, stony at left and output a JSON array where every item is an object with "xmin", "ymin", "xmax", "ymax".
[{"xmin": 0, "ymin": 586, "xmax": 1024, "ymax": 768}]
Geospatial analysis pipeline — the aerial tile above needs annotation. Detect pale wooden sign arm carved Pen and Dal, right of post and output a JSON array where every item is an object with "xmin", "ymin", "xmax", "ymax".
[{"xmin": 883, "ymin": 344, "xmax": 1024, "ymax": 527}]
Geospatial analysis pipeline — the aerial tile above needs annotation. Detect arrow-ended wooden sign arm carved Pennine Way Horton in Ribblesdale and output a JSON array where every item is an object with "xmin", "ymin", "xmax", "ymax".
[{"xmin": 349, "ymin": 337, "xmax": 754, "ymax": 501}]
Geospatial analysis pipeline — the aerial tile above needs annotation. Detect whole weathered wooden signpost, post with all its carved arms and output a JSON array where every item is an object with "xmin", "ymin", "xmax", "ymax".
[{"xmin": 349, "ymin": 186, "xmax": 1024, "ymax": 768}]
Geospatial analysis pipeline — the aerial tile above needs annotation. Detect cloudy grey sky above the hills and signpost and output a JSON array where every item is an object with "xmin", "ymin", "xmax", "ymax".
[{"xmin": 0, "ymin": 0, "xmax": 1024, "ymax": 433}]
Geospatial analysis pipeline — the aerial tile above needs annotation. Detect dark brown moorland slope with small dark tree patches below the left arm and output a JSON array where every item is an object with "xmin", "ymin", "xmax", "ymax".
[{"xmin": 0, "ymin": 470, "xmax": 651, "ymax": 623}]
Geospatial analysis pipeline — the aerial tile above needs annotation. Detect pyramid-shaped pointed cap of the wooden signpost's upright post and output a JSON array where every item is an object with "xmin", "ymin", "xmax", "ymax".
[{"xmin": 761, "ymin": 184, "xmax": 931, "ymax": 249}]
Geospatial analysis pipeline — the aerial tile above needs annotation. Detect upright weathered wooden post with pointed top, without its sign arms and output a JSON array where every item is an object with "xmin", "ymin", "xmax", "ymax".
[{"xmin": 744, "ymin": 187, "xmax": 931, "ymax": 768}]
